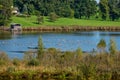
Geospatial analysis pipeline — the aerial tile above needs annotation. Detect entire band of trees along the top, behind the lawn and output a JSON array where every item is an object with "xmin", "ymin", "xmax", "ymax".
[{"xmin": 0, "ymin": 0, "xmax": 120, "ymax": 25}]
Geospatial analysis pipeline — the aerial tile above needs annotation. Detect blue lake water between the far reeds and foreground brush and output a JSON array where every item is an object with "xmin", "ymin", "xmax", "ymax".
[{"xmin": 0, "ymin": 31, "xmax": 120, "ymax": 58}]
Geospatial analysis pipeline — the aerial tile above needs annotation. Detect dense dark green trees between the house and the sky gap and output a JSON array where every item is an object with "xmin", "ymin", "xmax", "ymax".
[{"xmin": 14, "ymin": 0, "xmax": 97, "ymax": 18}]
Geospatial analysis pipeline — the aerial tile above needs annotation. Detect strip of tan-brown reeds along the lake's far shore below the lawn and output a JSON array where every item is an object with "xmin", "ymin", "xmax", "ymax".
[{"xmin": 0, "ymin": 26, "xmax": 120, "ymax": 32}]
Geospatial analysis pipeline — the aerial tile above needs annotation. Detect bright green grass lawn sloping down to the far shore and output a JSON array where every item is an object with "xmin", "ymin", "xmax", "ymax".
[{"xmin": 12, "ymin": 16, "xmax": 120, "ymax": 27}]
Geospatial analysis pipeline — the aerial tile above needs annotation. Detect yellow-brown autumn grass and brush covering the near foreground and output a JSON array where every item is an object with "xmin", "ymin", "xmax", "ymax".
[{"xmin": 0, "ymin": 48, "xmax": 120, "ymax": 80}]
